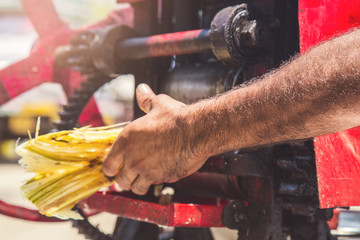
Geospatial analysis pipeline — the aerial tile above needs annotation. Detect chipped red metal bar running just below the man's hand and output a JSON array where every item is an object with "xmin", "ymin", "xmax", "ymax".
[{"xmin": 79, "ymin": 193, "xmax": 225, "ymax": 227}]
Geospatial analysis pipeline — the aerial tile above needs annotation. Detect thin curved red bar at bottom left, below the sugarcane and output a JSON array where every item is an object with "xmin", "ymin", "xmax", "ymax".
[{"xmin": 0, "ymin": 201, "xmax": 62, "ymax": 222}]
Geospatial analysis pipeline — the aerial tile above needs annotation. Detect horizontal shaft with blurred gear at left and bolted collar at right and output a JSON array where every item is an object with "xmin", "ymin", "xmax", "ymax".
[{"xmin": 55, "ymin": 4, "xmax": 269, "ymax": 76}]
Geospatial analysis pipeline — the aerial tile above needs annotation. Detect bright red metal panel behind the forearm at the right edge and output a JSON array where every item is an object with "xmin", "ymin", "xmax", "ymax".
[{"xmin": 299, "ymin": 0, "xmax": 360, "ymax": 208}]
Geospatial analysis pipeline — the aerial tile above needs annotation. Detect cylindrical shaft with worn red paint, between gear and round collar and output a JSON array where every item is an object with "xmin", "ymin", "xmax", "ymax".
[{"xmin": 116, "ymin": 29, "xmax": 211, "ymax": 59}]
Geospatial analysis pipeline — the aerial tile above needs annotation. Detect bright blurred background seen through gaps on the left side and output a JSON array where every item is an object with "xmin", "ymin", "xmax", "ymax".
[{"xmin": 0, "ymin": 0, "xmax": 134, "ymax": 240}]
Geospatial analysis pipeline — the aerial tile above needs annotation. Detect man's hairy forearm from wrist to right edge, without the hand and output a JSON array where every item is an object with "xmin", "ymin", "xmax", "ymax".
[{"xmin": 187, "ymin": 30, "xmax": 360, "ymax": 157}]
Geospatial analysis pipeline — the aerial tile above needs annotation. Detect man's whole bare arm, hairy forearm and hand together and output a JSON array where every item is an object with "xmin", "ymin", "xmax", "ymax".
[{"xmin": 103, "ymin": 30, "xmax": 360, "ymax": 194}]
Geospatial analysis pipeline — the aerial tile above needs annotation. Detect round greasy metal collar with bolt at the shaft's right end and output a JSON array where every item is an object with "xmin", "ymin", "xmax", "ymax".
[{"xmin": 210, "ymin": 3, "xmax": 271, "ymax": 67}]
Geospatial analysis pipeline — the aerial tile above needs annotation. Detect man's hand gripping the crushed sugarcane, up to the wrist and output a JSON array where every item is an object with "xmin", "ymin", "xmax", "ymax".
[{"xmin": 103, "ymin": 84, "xmax": 207, "ymax": 195}]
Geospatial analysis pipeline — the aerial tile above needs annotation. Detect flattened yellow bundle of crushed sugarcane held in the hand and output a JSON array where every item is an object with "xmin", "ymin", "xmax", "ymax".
[{"xmin": 16, "ymin": 124, "xmax": 124, "ymax": 219}]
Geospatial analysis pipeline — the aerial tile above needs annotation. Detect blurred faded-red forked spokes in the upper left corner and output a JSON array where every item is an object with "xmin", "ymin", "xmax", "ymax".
[{"xmin": 0, "ymin": 0, "xmax": 75, "ymax": 104}]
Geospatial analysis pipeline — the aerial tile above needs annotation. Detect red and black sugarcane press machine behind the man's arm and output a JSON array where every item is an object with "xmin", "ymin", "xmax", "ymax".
[{"xmin": 0, "ymin": 0, "xmax": 360, "ymax": 240}]
